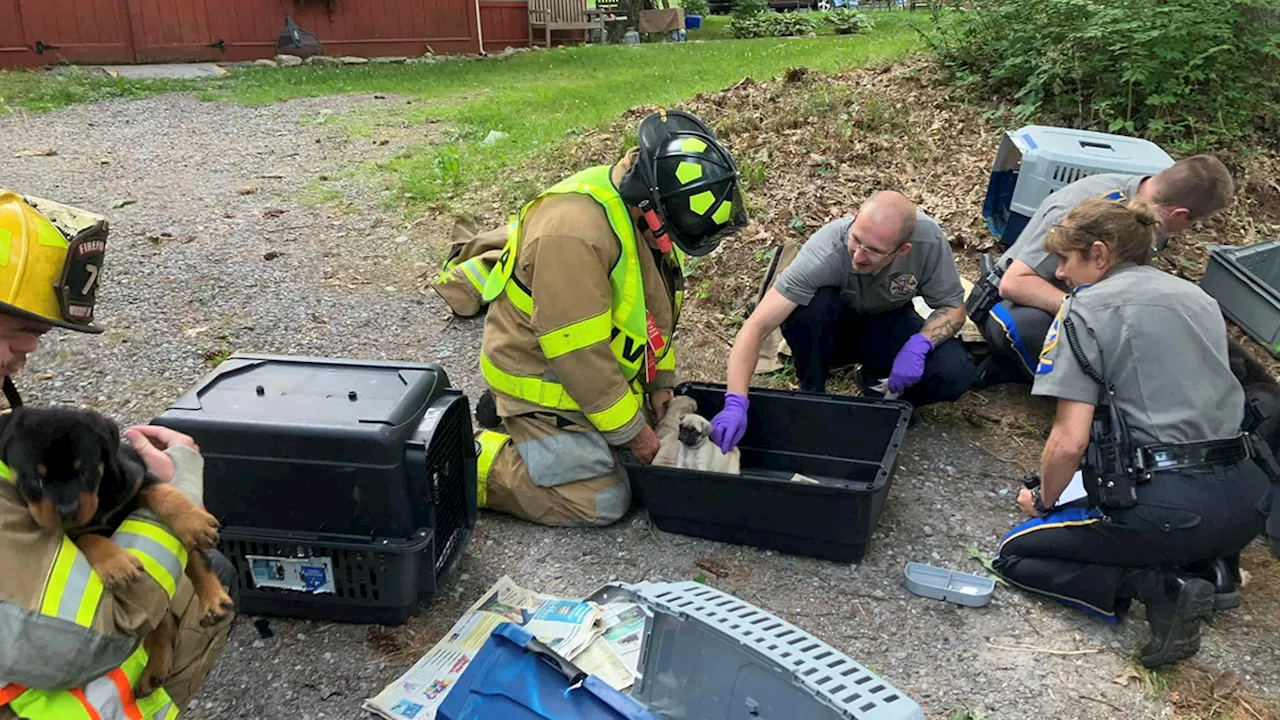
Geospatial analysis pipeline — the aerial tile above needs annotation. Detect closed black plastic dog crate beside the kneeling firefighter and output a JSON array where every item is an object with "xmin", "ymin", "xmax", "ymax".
[{"xmin": 155, "ymin": 355, "xmax": 476, "ymax": 624}]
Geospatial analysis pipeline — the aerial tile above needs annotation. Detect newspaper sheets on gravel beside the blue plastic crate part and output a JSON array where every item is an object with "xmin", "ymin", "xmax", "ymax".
[{"xmin": 364, "ymin": 577, "xmax": 632, "ymax": 720}]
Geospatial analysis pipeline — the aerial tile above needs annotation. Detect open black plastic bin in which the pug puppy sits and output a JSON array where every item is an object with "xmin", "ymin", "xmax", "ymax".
[{"xmin": 626, "ymin": 383, "xmax": 911, "ymax": 562}]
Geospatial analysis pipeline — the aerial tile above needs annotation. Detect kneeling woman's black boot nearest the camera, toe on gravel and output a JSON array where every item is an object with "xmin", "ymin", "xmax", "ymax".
[{"xmin": 1120, "ymin": 569, "xmax": 1213, "ymax": 667}]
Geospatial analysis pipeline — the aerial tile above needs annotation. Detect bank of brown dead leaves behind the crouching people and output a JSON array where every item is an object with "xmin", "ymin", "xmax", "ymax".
[{"xmin": 474, "ymin": 60, "xmax": 1280, "ymax": 384}]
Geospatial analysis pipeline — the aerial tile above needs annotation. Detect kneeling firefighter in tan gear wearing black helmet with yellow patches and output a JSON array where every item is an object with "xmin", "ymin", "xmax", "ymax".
[{"xmin": 436, "ymin": 110, "xmax": 746, "ymax": 525}]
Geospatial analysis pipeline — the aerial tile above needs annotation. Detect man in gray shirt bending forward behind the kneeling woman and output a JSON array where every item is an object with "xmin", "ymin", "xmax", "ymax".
[{"xmin": 982, "ymin": 155, "xmax": 1234, "ymax": 383}]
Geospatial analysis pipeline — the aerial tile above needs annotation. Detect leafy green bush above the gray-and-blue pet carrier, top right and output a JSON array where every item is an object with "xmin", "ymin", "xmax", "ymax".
[{"xmin": 931, "ymin": 0, "xmax": 1280, "ymax": 150}]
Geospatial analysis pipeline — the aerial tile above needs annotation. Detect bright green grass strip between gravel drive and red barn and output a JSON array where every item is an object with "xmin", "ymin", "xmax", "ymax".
[{"xmin": 0, "ymin": 18, "xmax": 916, "ymax": 209}]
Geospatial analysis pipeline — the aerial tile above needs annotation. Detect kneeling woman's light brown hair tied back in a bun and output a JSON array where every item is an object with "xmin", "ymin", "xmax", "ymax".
[{"xmin": 1044, "ymin": 197, "xmax": 1160, "ymax": 265}]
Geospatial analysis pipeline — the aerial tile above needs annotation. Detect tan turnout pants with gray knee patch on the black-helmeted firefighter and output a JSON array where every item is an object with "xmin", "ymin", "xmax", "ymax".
[{"xmin": 477, "ymin": 413, "xmax": 631, "ymax": 527}]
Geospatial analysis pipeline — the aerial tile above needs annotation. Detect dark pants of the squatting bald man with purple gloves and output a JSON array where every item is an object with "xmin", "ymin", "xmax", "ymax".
[{"xmin": 782, "ymin": 287, "xmax": 977, "ymax": 406}]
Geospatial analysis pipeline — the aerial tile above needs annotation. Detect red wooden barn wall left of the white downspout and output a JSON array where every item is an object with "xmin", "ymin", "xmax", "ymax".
[{"xmin": 0, "ymin": 0, "xmax": 486, "ymax": 67}]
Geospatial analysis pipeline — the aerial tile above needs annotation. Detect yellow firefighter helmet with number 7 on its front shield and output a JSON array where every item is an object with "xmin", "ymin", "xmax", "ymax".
[{"xmin": 0, "ymin": 190, "xmax": 108, "ymax": 333}]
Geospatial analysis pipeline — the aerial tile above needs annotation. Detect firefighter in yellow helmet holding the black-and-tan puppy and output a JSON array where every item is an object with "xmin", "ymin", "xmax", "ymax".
[{"xmin": 0, "ymin": 191, "xmax": 236, "ymax": 720}]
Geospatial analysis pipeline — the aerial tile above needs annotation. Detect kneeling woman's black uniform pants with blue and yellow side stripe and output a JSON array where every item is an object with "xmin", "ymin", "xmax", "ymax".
[{"xmin": 995, "ymin": 460, "xmax": 1270, "ymax": 621}]
